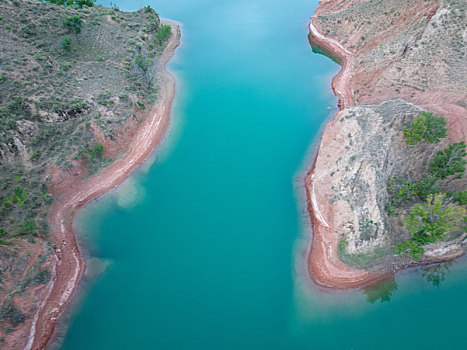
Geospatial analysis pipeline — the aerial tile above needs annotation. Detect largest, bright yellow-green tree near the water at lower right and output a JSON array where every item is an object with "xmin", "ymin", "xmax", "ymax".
[{"xmin": 396, "ymin": 193, "xmax": 467, "ymax": 260}]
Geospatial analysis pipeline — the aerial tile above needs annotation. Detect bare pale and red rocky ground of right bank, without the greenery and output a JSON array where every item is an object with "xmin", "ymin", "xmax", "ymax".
[{"xmin": 306, "ymin": 0, "xmax": 467, "ymax": 288}]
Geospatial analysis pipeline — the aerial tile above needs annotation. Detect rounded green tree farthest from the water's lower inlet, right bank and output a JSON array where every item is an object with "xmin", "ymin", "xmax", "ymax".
[{"xmin": 403, "ymin": 112, "xmax": 447, "ymax": 145}]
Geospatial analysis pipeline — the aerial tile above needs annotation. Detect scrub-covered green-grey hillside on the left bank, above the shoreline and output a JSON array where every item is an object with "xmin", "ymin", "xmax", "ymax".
[{"xmin": 0, "ymin": 0, "xmax": 176, "ymax": 348}]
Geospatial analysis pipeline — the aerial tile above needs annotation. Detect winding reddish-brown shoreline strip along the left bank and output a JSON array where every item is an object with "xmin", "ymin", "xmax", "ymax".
[{"xmin": 25, "ymin": 20, "xmax": 181, "ymax": 350}]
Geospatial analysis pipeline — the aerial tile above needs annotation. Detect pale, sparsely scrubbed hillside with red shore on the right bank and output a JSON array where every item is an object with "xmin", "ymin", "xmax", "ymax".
[{"xmin": 307, "ymin": 0, "xmax": 467, "ymax": 288}]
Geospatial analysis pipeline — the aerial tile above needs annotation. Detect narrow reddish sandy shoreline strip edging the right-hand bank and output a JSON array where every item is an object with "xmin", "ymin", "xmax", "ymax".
[{"xmin": 305, "ymin": 17, "xmax": 390, "ymax": 289}]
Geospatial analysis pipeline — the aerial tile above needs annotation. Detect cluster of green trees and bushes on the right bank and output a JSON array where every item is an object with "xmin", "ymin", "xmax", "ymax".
[{"xmin": 386, "ymin": 112, "xmax": 467, "ymax": 261}]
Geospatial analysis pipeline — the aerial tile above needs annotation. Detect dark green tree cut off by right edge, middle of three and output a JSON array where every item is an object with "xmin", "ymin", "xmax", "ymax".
[{"xmin": 430, "ymin": 141, "xmax": 467, "ymax": 179}]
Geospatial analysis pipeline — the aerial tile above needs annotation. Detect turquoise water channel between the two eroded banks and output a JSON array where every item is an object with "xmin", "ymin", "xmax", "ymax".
[{"xmin": 62, "ymin": 0, "xmax": 467, "ymax": 350}]
